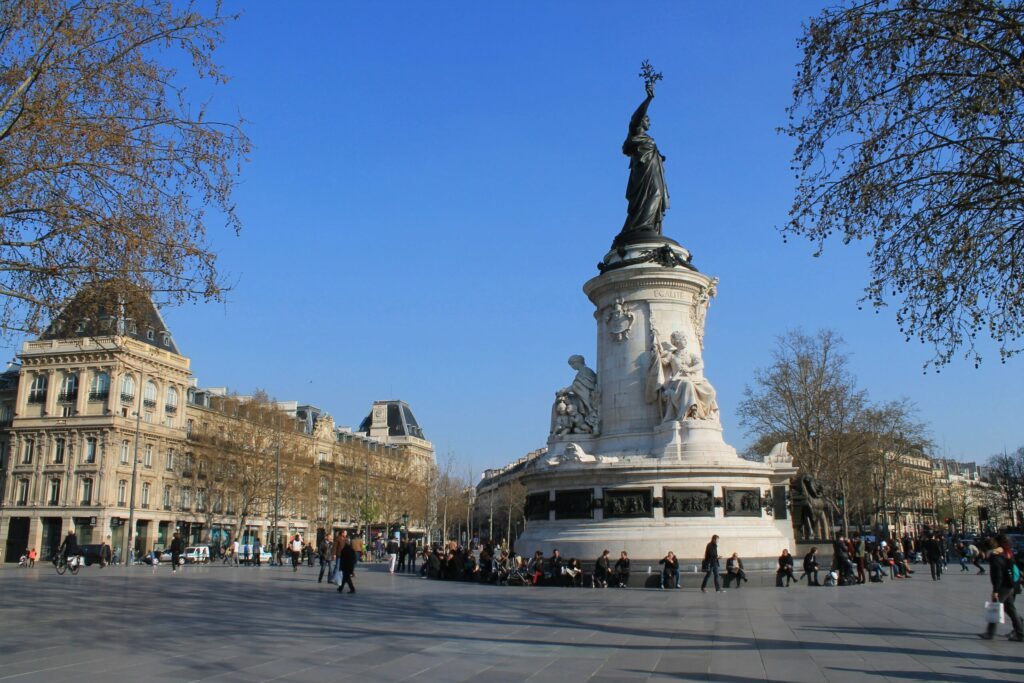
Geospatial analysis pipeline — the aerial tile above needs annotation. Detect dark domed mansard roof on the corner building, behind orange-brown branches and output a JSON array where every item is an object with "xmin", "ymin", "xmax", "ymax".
[{"xmin": 39, "ymin": 281, "xmax": 181, "ymax": 355}]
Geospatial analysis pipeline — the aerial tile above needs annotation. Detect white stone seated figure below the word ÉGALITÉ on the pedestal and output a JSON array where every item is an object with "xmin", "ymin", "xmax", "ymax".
[{"xmin": 646, "ymin": 328, "xmax": 718, "ymax": 422}]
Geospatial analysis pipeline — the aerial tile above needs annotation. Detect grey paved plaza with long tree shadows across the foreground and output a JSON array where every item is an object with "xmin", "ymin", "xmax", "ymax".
[{"xmin": 0, "ymin": 563, "xmax": 1024, "ymax": 683}]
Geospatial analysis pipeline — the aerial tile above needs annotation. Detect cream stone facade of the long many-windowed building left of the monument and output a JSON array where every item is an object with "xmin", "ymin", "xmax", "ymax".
[{"xmin": 0, "ymin": 290, "xmax": 433, "ymax": 562}]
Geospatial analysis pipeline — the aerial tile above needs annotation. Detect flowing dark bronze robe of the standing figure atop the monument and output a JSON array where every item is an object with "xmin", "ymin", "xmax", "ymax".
[{"xmin": 622, "ymin": 133, "xmax": 669, "ymax": 234}]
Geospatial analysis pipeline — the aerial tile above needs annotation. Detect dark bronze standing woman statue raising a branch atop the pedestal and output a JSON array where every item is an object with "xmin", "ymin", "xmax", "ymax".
[{"xmin": 618, "ymin": 61, "xmax": 669, "ymax": 239}]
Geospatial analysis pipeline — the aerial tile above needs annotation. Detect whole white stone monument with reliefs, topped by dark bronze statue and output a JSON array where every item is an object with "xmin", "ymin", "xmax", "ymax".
[{"xmin": 516, "ymin": 72, "xmax": 796, "ymax": 570}]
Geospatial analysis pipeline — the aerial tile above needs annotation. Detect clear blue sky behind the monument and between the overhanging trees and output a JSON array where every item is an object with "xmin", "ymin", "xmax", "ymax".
[{"xmin": 9, "ymin": 2, "xmax": 1024, "ymax": 474}]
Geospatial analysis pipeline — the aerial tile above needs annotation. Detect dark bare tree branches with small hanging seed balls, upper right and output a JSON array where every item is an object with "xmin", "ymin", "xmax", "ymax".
[{"xmin": 783, "ymin": 0, "xmax": 1024, "ymax": 365}]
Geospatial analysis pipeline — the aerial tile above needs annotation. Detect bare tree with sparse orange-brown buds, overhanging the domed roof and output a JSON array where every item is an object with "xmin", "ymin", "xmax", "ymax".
[{"xmin": 0, "ymin": 0, "xmax": 249, "ymax": 333}]
